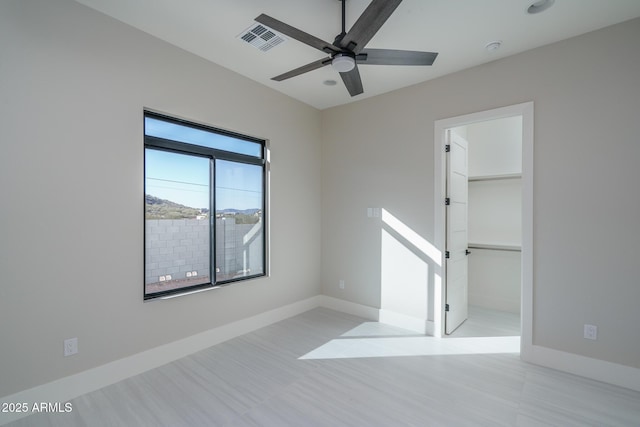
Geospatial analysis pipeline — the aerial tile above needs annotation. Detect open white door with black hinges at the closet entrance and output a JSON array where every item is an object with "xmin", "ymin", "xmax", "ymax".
[{"xmin": 445, "ymin": 130, "xmax": 468, "ymax": 334}]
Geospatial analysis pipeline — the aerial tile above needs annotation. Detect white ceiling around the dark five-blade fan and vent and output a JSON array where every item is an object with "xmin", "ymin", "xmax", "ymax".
[{"xmin": 76, "ymin": 0, "xmax": 640, "ymax": 109}]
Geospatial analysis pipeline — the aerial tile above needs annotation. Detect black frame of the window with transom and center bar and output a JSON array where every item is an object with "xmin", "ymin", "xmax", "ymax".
[{"xmin": 142, "ymin": 110, "xmax": 268, "ymax": 301}]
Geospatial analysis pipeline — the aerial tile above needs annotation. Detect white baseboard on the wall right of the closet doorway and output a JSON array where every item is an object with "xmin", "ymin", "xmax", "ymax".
[{"xmin": 521, "ymin": 345, "xmax": 640, "ymax": 391}]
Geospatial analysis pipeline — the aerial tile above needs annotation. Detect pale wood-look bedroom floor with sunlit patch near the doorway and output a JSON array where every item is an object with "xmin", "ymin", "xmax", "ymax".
[{"xmin": 10, "ymin": 308, "xmax": 640, "ymax": 427}]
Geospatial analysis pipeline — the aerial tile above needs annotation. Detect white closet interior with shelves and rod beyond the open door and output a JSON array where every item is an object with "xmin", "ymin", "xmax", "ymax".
[{"xmin": 454, "ymin": 116, "xmax": 522, "ymax": 314}]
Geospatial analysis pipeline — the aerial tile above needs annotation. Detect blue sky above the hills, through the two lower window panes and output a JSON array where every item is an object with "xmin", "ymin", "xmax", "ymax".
[{"xmin": 145, "ymin": 148, "xmax": 262, "ymax": 210}]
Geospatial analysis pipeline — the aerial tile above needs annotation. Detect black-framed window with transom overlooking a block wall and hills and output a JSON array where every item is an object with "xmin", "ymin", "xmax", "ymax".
[{"xmin": 144, "ymin": 112, "xmax": 266, "ymax": 299}]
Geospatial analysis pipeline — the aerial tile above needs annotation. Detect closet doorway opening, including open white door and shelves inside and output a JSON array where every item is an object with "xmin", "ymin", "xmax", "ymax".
[{"xmin": 445, "ymin": 116, "xmax": 522, "ymax": 337}]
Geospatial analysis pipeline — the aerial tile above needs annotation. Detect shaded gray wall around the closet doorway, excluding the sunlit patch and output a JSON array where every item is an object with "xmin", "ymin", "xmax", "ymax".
[{"xmin": 322, "ymin": 19, "xmax": 640, "ymax": 368}]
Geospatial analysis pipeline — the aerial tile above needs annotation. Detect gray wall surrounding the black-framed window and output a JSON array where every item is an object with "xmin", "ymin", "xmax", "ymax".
[{"xmin": 0, "ymin": 0, "xmax": 321, "ymax": 396}]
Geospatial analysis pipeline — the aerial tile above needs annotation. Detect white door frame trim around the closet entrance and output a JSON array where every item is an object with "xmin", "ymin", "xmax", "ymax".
[{"xmin": 433, "ymin": 102, "xmax": 533, "ymax": 358}]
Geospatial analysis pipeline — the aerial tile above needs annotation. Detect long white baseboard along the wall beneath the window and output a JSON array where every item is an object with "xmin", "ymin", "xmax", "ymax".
[{"xmin": 0, "ymin": 296, "xmax": 322, "ymax": 425}]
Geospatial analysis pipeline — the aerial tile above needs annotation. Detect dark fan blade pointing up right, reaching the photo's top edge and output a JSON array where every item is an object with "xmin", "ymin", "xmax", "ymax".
[{"xmin": 340, "ymin": 0, "xmax": 402, "ymax": 53}]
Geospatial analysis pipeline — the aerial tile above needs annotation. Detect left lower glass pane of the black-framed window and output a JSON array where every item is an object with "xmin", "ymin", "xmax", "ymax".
[{"xmin": 145, "ymin": 148, "xmax": 211, "ymax": 294}]
